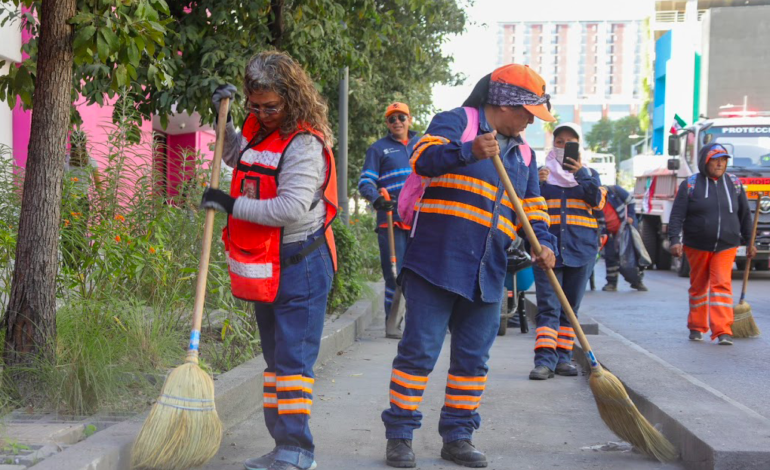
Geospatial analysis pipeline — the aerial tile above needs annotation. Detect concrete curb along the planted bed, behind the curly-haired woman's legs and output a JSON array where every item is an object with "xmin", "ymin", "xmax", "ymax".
[{"xmin": 34, "ymin": 282, "xmax": 384, "ymax": 470}]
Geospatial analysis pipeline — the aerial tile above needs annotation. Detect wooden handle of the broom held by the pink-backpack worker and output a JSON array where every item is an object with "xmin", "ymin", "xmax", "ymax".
[{"xmin": 492, "ymin": 155, "xmax": 601, "ymax": 369}]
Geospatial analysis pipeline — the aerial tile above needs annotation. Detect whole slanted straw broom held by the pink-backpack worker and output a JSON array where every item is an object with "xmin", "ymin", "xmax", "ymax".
[{"xmin": 492, "ymin": 155, "xmax": 678, "ymax": 462}]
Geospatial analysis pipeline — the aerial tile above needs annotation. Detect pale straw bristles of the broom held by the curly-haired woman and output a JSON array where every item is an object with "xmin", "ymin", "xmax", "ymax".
[{"xmin": 131, "ymin": 362, "xmax": 222, "ymax": 470}]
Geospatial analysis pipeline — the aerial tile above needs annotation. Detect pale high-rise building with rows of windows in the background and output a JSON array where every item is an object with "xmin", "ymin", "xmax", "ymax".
[{"xmin": 498, "ymin": 8, "xmax": 650, "ymax": 148}]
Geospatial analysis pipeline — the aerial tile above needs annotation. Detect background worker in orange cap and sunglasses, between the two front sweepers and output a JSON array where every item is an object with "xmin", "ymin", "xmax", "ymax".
[{"xmin": 358, "ymin": 103, "xmax": 417, "ymax": 330}]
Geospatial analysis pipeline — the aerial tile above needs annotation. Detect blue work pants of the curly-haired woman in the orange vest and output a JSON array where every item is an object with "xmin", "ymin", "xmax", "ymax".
[{"xmin": 255, "ymin": 231, "xmax": 334, "ymax": 469}]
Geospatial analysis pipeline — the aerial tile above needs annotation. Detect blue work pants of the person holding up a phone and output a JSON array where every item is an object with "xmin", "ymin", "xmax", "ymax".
[{"xmin": 534, "ymin": 261, "xmax": 594, "ymax": 370}]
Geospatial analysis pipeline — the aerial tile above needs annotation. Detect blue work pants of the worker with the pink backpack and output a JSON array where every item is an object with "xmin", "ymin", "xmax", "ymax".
[{"xmin": 382, "ymin": 270, "xmax": 500, "ymax": 442}]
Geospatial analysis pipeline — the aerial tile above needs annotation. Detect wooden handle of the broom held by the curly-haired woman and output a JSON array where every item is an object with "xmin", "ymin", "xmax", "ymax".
[{"xmin": 187, "ymin": 94, "xmax": 230, "ymax": 364}]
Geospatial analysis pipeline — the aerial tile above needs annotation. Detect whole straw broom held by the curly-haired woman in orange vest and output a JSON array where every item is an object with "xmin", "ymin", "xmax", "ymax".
[{"xmin": 131, "ymin": 98, "xmax": 230, "ymax": 470}]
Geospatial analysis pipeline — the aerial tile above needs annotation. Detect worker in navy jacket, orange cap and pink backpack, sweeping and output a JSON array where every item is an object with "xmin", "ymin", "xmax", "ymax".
[{"xmin": 382, "ymin": 64, "xmax": 556, "ymax": 467}]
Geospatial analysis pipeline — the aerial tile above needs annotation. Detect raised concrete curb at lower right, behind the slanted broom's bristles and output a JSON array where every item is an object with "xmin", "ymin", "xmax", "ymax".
[{"xmin": 575, "ymin": 326, "xmax": 770, "ymax": 470}]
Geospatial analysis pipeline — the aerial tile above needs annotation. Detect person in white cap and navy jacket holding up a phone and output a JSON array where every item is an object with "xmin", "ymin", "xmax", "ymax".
[{"xmin": 529, "ymin": 123, "xmax": 607, "ymax": 380}]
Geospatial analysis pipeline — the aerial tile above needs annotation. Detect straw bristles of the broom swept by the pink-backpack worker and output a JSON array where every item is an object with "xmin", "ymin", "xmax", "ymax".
[{"xmin": 588, "ymin": 368, "xmax": 679, "ymax": 462}]
